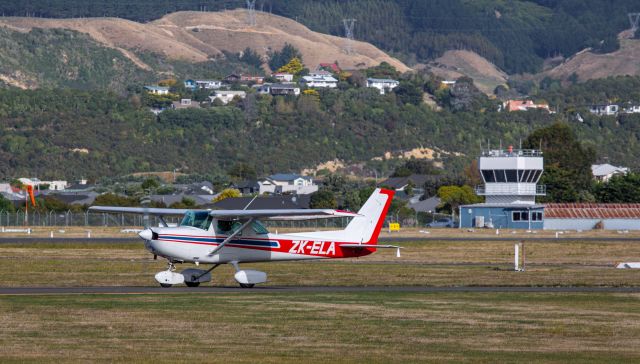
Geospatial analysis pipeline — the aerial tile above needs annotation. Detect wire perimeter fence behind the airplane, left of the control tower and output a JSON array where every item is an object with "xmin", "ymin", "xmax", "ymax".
[{"xmin": 0, "ymin": 211, "xmax": 450, "ymax": 229}]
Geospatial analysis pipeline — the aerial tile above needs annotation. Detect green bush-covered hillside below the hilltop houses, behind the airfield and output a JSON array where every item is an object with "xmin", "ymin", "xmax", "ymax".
[{"xmin": 0, "ymin": 78, "xmax": 640, "ymax": 180}]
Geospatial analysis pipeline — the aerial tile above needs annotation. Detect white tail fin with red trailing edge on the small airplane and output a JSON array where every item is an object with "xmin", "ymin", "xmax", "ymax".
[{"xmin": 344, "ymin": 188, "xmax": 395, "ymax": 244}]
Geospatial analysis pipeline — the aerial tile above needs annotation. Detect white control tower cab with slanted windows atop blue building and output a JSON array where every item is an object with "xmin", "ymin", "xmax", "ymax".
[{"xmin": 476, "ymin": 146, "xmax": 546, "ymax": 205}]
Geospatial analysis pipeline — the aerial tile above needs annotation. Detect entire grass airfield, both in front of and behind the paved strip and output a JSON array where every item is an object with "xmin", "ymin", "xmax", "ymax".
[{"xmin": 0, "ymin": 240, "xmax": 640, "ymax": 363}]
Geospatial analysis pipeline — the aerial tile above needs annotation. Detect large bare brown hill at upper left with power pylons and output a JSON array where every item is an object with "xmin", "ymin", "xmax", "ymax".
[{"xmin": 0, "ymin": 10, "xmax": 409, "ymax": 72}]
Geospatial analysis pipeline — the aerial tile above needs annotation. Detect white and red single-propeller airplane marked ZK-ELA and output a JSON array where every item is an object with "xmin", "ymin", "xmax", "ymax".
[{"xmin": 89, "ymin": 188, "xmax": 401, "ymax": 288}]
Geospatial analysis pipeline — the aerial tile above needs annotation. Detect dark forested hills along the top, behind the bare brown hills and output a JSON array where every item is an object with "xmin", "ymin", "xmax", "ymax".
[{"xmin": 0, "ymin": 0, "xmax": 640, "ymax": 74}]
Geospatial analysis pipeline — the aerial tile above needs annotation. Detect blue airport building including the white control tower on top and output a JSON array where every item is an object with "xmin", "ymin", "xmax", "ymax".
[{"xmin": 458, "ymin": 147, "xmax": 546, "ymax": 230}]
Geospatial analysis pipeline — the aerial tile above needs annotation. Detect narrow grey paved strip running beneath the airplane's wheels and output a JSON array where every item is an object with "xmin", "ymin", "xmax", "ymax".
[{"xmin": 0, "ymin": 286, "xmax": 640, "ymax": 296}]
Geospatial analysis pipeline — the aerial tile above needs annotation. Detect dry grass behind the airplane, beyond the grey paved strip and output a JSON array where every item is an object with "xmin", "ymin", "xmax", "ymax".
[{"xmin": 0, "ymin": 241, "xmax": 640, "ymax": 287}]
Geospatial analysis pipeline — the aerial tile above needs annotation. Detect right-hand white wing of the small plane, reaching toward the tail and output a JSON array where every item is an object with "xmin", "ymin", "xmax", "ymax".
[{"xmin": 209, "ymin": 209, "xmax": 360, "ymax": 220}]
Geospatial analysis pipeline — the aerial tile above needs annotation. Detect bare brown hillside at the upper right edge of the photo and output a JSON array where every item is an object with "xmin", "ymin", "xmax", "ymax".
[{"xmin": 541, "ymin": 32, "xmax": 640, "ymax": 81}]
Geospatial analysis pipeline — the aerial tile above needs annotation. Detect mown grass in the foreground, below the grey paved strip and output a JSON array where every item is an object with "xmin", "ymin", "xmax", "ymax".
[{"xmin": 0, "ymin": 292, "xmax": 640, "ymax": 363}]
